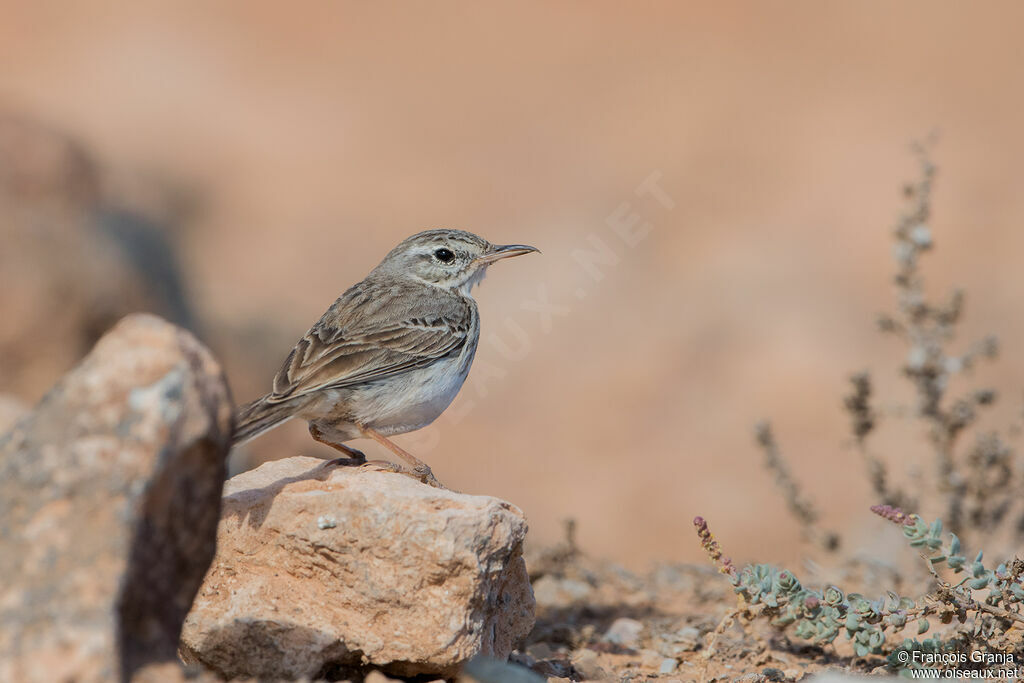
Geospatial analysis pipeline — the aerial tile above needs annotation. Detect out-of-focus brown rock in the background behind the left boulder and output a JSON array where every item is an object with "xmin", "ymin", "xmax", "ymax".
[{"xmin": 0, "ymin": 112, "xmax": 195, "ymax": 400}]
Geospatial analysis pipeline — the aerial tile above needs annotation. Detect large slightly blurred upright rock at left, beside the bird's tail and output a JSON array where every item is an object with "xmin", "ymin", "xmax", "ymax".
[{"xmin": 0, "ymin": 315, "xmax": 232, "ymax": 683}]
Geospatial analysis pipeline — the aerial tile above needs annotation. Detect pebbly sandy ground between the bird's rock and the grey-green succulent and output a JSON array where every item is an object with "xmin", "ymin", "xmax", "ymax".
[{"xmin": 511, "ymin": 532, "xmax": 913, "ymax": 683}]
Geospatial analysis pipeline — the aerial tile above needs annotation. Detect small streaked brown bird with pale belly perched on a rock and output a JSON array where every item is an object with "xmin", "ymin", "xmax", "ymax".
[{"xmin": 234, "ymin": 229, "xmax": 538, "ymax": 485}]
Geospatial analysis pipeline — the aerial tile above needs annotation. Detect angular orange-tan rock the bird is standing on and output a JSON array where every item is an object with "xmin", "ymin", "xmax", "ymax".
[{"xmin": 182, "ymin": 458, "xmax": 534, "ymax": 678}]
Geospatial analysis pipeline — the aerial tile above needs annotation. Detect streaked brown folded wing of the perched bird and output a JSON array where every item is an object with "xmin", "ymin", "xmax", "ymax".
[{"xmin": 267, "ymin": 286, "xmax": 472, "ymax": 402}]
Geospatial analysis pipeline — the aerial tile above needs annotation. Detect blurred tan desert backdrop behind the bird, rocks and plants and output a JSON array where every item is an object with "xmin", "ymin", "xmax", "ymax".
[{"xmin": 0, "ymin": 0, "xmax": 1024, "ymax": 568}]
